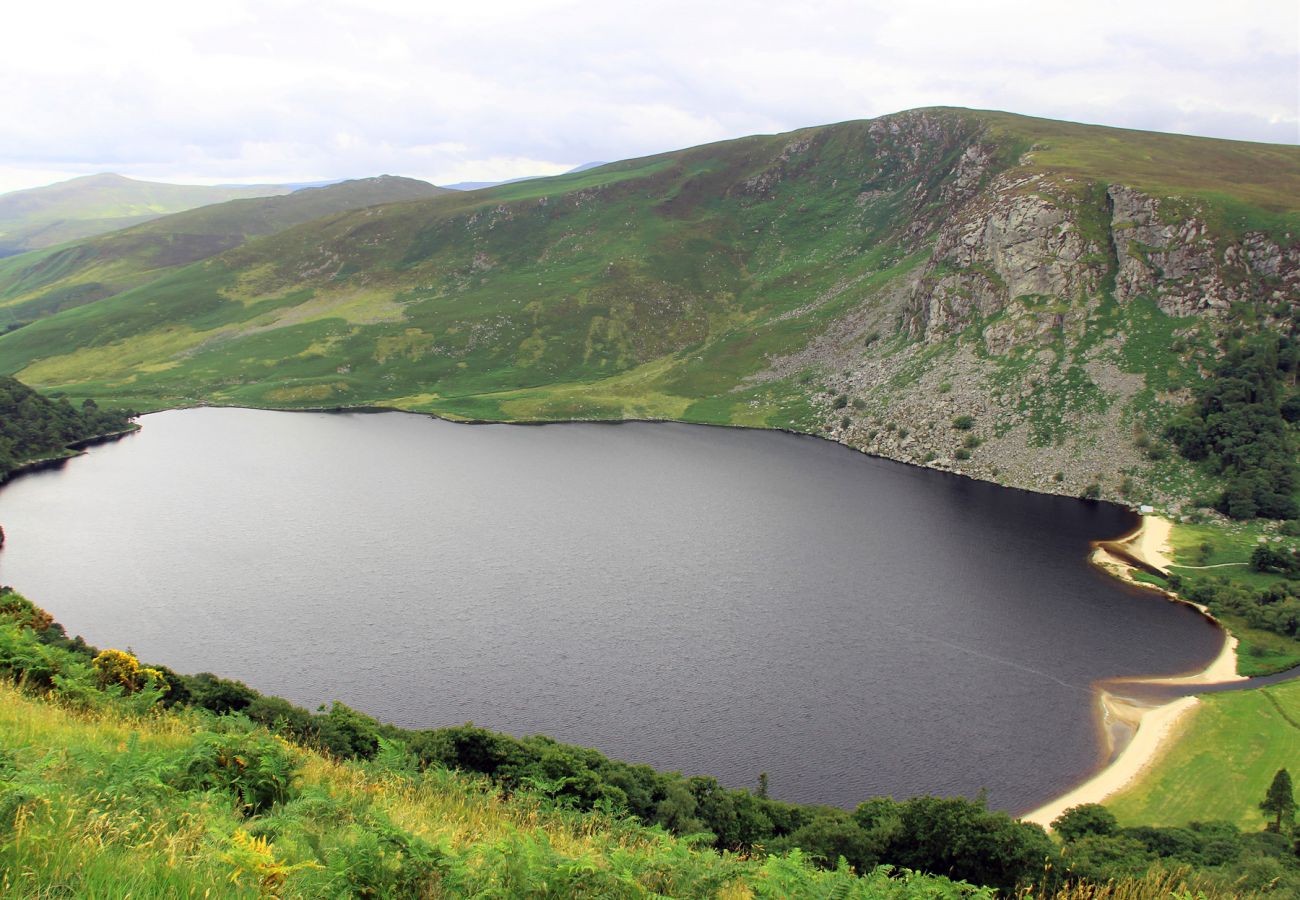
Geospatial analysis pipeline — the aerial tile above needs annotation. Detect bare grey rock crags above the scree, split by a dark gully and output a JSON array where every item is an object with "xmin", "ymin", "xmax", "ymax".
[{"xmin": 907, "ymin": 176, "xmax": 1300, "ymax": 340}]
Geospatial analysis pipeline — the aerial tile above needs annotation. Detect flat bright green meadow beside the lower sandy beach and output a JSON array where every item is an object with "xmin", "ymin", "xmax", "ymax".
[{"xmin": 1106, "ymin": 682, "xmax": 1300, "ymax": 831}]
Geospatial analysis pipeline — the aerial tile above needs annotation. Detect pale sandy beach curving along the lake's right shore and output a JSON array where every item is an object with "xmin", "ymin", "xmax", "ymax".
[{"xmin": 1017, "ymin": 515, "xmax": 1248, "ymax": 831}]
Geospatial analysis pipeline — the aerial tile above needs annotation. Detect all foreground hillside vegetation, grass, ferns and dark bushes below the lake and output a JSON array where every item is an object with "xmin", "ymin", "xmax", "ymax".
[{"xmin": 0, "ymin": 590, "xmax": 1295, "ymax": 899}]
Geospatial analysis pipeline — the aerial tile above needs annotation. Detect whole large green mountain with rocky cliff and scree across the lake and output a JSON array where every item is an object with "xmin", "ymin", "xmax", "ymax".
[{"xmin": 0, "ymin": 108, "xmax": 1300, "ymax": 503}]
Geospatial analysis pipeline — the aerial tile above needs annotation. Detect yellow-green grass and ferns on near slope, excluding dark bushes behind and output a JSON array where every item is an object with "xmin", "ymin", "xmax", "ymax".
[{"xmin": 0, "ymin": 683, "xmax": 993, "ymax": 897}]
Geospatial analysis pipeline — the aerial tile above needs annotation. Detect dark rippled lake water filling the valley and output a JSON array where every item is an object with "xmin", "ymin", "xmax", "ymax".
[{"xmin": 0, "ymin": 410, "xmax": 1221, "ymax": 812}]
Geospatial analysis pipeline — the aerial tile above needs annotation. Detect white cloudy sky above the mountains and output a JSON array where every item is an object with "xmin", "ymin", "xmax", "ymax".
[{"xmin": 0, "ymin": 0, "xmax": 1300, "ymax": 191}]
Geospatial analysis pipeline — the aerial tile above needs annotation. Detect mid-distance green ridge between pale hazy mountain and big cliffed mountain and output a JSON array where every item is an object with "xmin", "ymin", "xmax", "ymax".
[{"xmin": 0, "ymin": 176, "xmax": 445, "ymax": 329}]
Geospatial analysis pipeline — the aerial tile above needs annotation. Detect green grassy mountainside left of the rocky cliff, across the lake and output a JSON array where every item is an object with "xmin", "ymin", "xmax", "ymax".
[{"xmin": 4, "ymin": 115, "xmax": 925, "ymax": 420}]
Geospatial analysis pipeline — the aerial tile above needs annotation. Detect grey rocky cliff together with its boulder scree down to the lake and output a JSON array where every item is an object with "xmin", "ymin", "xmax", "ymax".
[{"xmin": 783, "ymin": 122, "xmax": 1300, "ymax": 503}]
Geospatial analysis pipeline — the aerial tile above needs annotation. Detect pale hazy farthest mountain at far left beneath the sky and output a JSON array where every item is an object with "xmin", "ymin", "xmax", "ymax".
[{"xmin": 0, "ymin": 173, "xmax": 293, "ymax": 256}]
